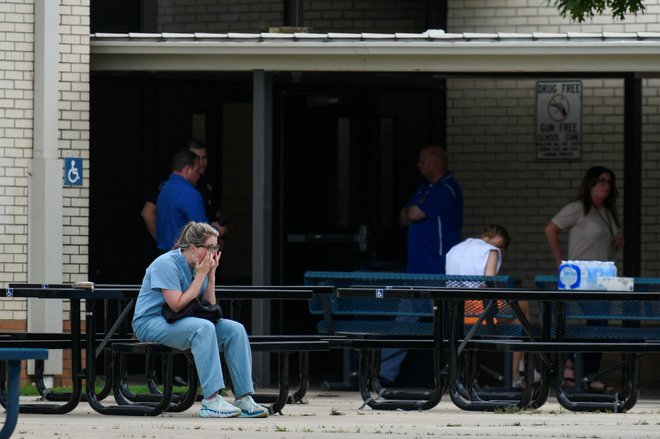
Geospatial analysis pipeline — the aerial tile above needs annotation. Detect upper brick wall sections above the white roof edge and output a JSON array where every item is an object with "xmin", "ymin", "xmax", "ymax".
[{"xmin": 152, "ymin": 0, "xmax": 660, "ymax": 33}]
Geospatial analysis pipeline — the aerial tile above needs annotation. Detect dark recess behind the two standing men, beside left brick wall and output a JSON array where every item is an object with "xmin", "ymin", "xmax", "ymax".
[{"xmin": 90, "ymin": 74, "xmax": 251, "ymax": 283}]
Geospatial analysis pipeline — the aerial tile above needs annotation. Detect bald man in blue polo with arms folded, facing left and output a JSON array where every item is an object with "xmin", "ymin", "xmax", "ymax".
[{"xmin": 380, "ymin": 146, "xmax": 463, "ymax": 386}]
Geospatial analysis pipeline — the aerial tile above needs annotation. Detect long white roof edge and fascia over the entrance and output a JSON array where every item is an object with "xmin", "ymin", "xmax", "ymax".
[{"xmin": 90, "ymin": 31, "xmax": 660, "ymax": 77}]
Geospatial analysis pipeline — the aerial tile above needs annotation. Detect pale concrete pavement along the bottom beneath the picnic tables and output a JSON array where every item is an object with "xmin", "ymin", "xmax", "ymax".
[{"xmin": 13, "ymin": 390, "xmax": 660, "ymax": 439}]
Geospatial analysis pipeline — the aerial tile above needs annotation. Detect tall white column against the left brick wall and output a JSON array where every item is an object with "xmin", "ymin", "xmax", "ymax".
[{"xmin": 27, "ymin": 1, "xmax": 63, "ymax": 375}]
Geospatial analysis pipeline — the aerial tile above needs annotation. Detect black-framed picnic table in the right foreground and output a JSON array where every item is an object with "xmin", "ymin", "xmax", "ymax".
[{"xmin": 337, "ymin": 286, "xmax": 660, "ymax": 412}]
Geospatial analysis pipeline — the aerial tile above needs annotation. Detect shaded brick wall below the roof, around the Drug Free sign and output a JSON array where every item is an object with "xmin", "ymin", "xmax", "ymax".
[{"xmin": 447, "ymin": 79, "xmax": 623, "ymax": 286}]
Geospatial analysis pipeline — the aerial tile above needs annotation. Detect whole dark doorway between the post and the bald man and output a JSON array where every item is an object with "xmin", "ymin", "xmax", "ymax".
[{"xmin": 272, "ymin": 75, "xmax": 444, "ymax": 381}]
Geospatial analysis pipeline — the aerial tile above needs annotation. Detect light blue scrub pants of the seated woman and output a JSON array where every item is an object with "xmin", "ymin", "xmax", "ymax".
[{"xmin": 135, "ymin": 316, "xmax": 254, "ymax": 398}]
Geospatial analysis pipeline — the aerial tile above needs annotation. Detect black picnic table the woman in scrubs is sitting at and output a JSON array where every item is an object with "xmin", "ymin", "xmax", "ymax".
[{"xmin": 0, "ymin": 283, "xmax": 331, "ymax": 415}]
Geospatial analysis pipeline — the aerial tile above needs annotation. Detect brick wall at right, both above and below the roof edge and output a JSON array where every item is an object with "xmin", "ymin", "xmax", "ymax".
[{"xmin": 447, "ymin": 0, "xmax": 660, "ymax": 286}]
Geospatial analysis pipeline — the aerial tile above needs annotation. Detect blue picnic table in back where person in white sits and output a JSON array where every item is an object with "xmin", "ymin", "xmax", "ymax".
[{"xmin": 305, "ymin": 271, "xmax": 520, "ymax": 410}]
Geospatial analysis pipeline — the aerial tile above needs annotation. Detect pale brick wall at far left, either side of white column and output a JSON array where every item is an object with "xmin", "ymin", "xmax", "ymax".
[{"xmin": 0, "ymin": 0, "xmax": 89, "ymax": 385}]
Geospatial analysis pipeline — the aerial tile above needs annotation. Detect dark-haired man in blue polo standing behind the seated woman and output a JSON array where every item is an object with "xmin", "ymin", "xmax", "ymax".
[{"xmin": 156, "ymin": 149, "xmax": 208, "ymax": 251}]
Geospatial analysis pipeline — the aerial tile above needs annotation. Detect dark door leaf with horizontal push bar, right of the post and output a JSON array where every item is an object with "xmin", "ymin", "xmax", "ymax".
[{"xmin": 282, "ymin": 93, "xmax": 379, "ymax": 283}]
